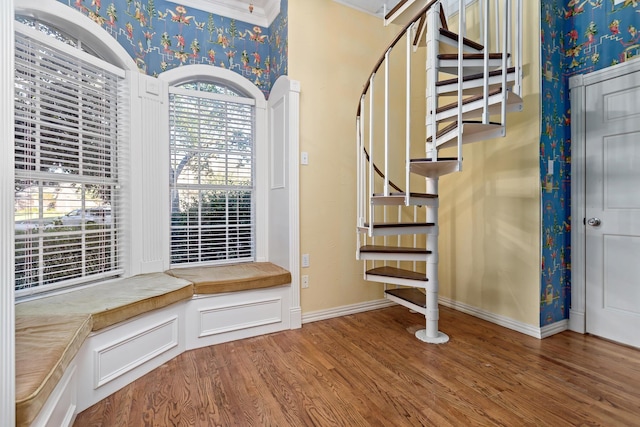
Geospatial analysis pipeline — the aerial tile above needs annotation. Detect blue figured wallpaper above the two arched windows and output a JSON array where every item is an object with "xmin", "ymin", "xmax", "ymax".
[{"xmin": 60, "ymin": 0, "xmax": 288, "ymax": 94}]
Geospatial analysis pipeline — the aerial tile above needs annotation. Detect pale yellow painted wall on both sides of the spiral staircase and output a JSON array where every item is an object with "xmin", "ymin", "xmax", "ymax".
[{"xmin": 289, "ymin": 0, "xmax": 540, "ymax": 325}]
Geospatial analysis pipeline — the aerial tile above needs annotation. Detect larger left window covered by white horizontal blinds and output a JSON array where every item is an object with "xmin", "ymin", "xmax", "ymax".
[{"xmin": 14, "ymin": 17, "xmax": 126, "ymax": 296}]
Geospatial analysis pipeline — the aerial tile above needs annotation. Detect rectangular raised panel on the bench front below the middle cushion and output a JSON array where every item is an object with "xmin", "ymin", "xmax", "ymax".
[{"xmin": 94, "ymin": 316, "xmax": 178, "ymax": 389}]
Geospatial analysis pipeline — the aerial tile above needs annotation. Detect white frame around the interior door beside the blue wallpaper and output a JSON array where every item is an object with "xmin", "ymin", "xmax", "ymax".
[{"xmin": 569, "ymin": 61, "xmax": 640, "ymax": 334}]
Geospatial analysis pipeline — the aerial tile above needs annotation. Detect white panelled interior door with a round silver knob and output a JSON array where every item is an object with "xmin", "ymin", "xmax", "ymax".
[{"xmin": 585, "ymin": 73, "xmax": 640, "ymax": 347}]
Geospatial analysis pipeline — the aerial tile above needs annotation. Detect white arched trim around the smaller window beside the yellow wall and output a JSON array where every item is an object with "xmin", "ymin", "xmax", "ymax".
[{"xmin": 158, "ymin": 65, "xmax": 269, "ymax": 268}]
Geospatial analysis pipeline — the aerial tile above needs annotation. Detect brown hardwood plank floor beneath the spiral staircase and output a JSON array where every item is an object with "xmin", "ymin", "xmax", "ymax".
[{"xmin": 74, "ymin": 306, "xmax": 640, "ymax": 427}]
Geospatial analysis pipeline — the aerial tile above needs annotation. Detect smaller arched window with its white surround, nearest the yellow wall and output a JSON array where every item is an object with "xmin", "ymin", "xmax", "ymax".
[{"xmin": 158, "ymin": 65, "xmax": 269, "ymax": 266}]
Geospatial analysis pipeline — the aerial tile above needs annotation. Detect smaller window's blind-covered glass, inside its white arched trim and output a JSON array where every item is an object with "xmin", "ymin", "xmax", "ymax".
[{"xmin": 169, "ymin": 82, "xmax": 255, "ymax": 265}]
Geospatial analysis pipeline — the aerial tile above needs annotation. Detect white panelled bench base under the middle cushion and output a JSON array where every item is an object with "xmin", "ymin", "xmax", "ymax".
[{"xmin": 78, "ymin": 302, "xmax": 186, "ymax": 412}]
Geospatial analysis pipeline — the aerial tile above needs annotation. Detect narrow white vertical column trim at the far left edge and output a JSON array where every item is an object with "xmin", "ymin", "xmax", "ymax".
[{"xmin": 0, "ymin": 0, "xmax": 16, "ymax": 426}]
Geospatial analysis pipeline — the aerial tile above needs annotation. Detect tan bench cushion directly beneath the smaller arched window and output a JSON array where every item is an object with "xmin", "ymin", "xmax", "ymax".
[{"xmin": 167, "ymin": 262, "xmax": 291, "ymax": 294}]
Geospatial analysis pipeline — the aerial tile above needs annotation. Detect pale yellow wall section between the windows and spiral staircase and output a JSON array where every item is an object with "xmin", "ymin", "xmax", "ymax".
[{"xmin": 289, "ymin": 0, "xmax": 395, "ymax": 313}]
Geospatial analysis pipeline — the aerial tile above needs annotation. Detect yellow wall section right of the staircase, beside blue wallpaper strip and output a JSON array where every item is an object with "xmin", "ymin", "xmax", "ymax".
[{"xmin": 439, "ymin": 2, "xmax": 540, "ymax": 327}]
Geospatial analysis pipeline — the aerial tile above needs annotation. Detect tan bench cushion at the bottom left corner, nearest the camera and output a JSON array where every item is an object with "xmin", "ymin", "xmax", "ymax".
[{"xmin": 16, "ymin": 314, "xmax": 92, "ymax": 426}]
